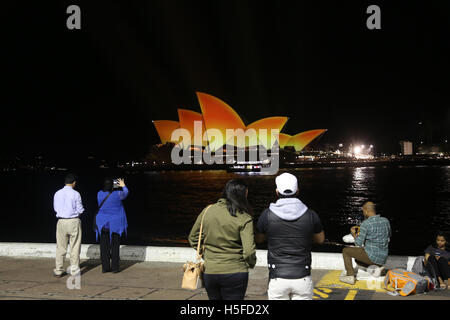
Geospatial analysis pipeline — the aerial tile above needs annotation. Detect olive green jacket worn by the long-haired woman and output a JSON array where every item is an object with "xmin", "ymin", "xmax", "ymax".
[{"xmin": 189, "ymin": 198, "xmax": 256, "ymax": 274}]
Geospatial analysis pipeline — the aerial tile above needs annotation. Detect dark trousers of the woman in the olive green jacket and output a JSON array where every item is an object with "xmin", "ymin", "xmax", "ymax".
[{"xmin": 203, "ymin": 272, "xmax": 248, "ymax": 300}]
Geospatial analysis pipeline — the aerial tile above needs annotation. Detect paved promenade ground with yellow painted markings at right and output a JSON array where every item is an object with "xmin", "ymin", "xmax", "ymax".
[{"xmin": 0, "ymin": 257, "xmax": 450, "ymax": 300}]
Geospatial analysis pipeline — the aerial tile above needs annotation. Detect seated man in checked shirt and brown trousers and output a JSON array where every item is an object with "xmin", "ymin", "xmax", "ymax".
[{"xmin": 339, "ymin": 201, "xmax": 392, "ymax": 284}]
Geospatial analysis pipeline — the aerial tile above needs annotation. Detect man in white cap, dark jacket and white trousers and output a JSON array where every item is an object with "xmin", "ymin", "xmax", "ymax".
[{"xmin": 256, "ymin": 173, "xmax": 325, "ymax": 300}]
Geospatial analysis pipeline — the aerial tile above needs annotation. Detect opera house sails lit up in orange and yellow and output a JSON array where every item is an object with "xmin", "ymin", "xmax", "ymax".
[{"xmin": 153, "ymin": 92, "xmax": 326, "ymax": 152}]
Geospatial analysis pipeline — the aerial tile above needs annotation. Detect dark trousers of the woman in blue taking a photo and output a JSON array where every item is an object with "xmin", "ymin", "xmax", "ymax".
[{"xmin": 100, "ymin": 230, "xmax": 120, "ymax": 272}]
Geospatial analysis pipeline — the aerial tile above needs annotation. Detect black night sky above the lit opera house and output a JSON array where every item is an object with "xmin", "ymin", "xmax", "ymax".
[{"xmin": 0, "ymin": 0, "xmax": 450, "ymax": 159}]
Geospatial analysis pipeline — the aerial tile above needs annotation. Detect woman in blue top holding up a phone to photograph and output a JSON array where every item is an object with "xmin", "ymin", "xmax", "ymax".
[{"xmin": 95, "ymin": 178, "xmax": 128, "ymax": 273}]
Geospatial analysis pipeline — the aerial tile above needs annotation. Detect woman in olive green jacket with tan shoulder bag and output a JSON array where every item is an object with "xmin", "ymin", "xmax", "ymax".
[{"xmin": 189, "ymin": 179, "xmax": 256, "ymax": 300}]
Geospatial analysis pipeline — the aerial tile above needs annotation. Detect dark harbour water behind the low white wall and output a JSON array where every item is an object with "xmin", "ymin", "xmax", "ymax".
[{"xmin": 0, "ymin": 167, "xmax": 450, "ymax": 255}]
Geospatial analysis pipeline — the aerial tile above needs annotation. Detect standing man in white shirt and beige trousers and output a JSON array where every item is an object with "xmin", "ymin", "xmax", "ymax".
[{"xmin": 53, "ymin": 174, "xmax": 84, "ymax": 278}]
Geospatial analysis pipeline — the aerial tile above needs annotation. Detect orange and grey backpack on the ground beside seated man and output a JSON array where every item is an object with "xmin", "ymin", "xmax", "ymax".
[{"xmin": 384, "ymin": 269, "xmax": 431, "ymax": 297}]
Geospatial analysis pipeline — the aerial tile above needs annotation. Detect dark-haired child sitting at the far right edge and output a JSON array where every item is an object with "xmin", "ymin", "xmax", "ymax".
[{"xmin": 424, "ymin": 231, "xmax": 450, "ymax": 289}]
